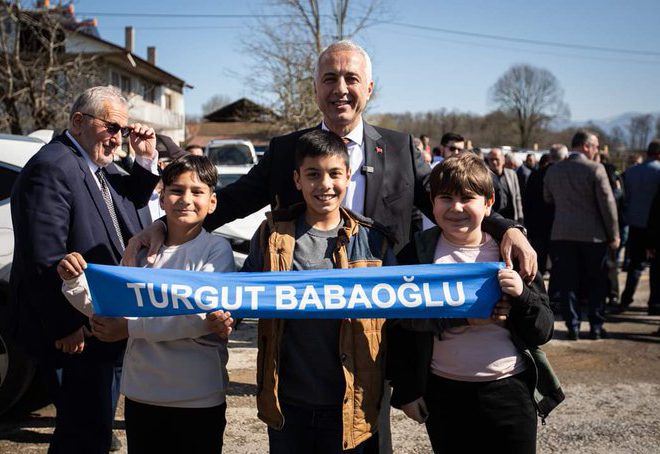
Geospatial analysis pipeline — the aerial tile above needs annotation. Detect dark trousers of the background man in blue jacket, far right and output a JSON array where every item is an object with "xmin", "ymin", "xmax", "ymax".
[{"xmin": 621, "ymin": 226, "xmax": 660, "ymax": 314}]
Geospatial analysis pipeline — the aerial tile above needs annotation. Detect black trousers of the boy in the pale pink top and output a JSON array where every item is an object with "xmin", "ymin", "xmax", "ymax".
[{"xmin": 424, "ymin": 373, "xmax": 536, "ymax": 454}]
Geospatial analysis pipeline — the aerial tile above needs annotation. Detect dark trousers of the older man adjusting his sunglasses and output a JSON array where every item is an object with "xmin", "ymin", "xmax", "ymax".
[{"xmin": 48, "ymin": 350, "xmax": 115, "ymax": 454}]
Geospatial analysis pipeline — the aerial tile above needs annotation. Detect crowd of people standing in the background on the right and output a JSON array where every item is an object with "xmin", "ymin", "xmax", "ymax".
[{"xmin": 413, "ymin": 130, "xmax": 660, "ymax": 340}]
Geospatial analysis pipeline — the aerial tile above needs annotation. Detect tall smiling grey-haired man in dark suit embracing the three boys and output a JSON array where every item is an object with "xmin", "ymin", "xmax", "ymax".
[{"xmin": 126, "ymin": 41, "xmax": 536, "ymax": 453}]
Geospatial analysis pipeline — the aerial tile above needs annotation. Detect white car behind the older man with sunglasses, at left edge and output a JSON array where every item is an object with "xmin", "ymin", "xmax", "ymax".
[{"xmin": 0, "ymin": 131, "xmax": 52, "ymax": 414}]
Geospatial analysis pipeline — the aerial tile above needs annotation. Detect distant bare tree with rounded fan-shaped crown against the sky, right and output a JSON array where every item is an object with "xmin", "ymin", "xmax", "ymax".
[{"xmin": 490, "ymin": 64, "xmax": 569, "ymax": 148}]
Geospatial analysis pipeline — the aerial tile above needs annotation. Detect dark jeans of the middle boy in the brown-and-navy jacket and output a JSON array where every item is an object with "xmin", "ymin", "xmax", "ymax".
[{"xmin": 268, "ymin": 403, "xmax": 368, "ymax": 454}]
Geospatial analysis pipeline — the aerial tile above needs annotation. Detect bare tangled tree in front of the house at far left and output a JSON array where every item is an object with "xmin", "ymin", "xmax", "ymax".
[{"xmin": 0, "ymin": 1, "xmax": 99, "ymax": 134}]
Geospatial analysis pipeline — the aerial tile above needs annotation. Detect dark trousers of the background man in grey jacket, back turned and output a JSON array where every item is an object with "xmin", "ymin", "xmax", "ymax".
[{"xmin": 551, "ymin": 241, "xmax": 607, "ymax": 331}]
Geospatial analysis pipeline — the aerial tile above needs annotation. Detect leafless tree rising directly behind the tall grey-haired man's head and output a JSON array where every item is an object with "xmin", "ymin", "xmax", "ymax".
[{"xmin": 245, "ymin": 0, "xmax": 386, "ymax": 130}]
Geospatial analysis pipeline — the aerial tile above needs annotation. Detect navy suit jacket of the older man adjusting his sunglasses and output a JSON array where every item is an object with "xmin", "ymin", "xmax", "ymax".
[{"xmin": 10, "ymin": 131, "xmax": 159, "ymax": 356}]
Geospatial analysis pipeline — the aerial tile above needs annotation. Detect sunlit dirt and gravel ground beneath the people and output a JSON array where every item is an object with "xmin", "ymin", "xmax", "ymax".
[{"xmin": 0, "ymin": 273, "xmax": 660, "ymax": 454}]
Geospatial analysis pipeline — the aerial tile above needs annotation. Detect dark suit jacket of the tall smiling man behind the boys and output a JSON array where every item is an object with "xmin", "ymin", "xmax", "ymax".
[{"xmin": 205, "ymin": 123, "xmax": 433, "ymax": 250}]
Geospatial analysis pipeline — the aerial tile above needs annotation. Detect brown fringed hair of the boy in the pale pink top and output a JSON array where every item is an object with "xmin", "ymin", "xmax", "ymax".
[{"xmin": 430, "ymin": 153, "xmax": 495, "ymax": 200}]
